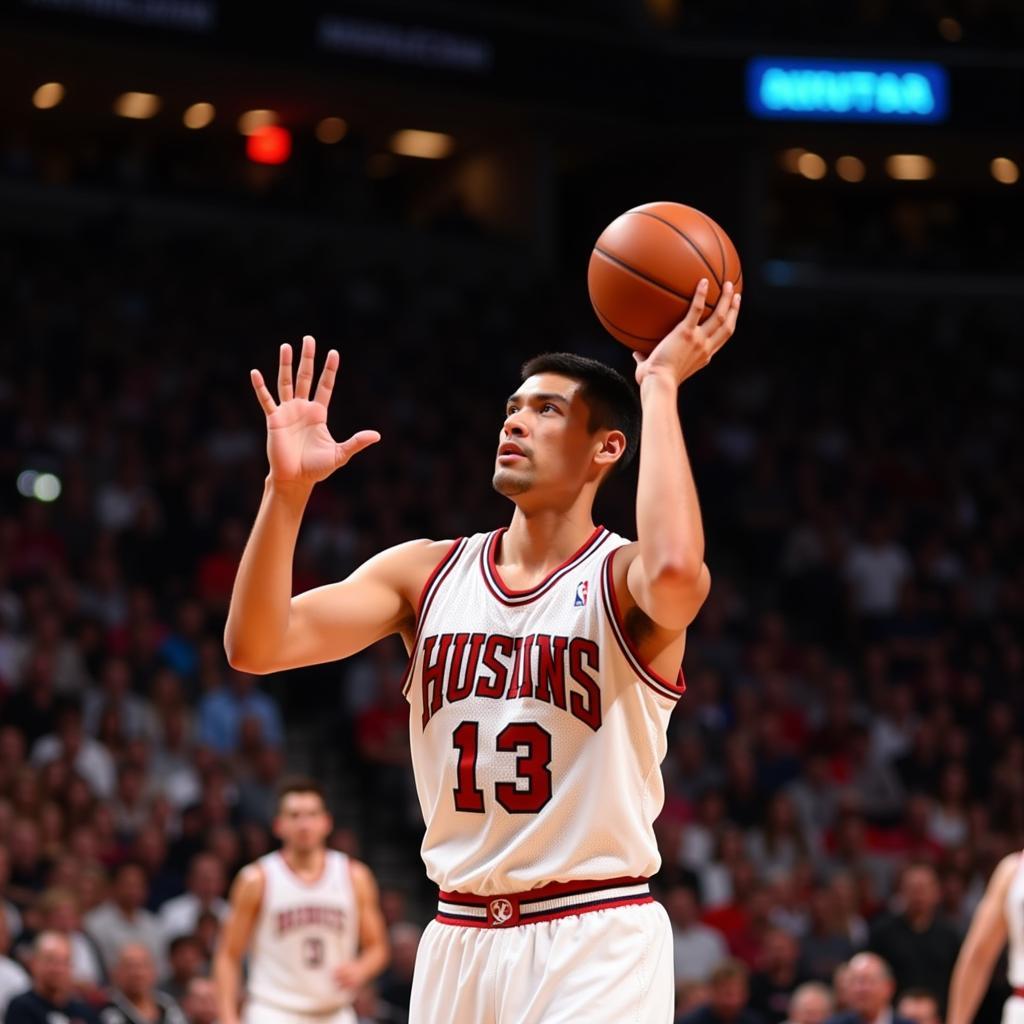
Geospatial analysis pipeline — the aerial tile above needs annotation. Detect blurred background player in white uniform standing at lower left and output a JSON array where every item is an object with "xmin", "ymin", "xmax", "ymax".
[{"xmin": 213, "ymin": 778, "xmax": 388, "ymax": 1024}]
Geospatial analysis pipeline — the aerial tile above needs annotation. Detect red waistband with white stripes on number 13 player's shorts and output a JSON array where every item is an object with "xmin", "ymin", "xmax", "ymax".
[{"xmin": 436, "ymin": 879, "xmax": 654, "ymax": 928}]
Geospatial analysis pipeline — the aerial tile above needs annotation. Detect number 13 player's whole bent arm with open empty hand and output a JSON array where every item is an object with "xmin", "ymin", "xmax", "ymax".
[{"xmin": 224, "ymin": 336, "xmax": 446, "ymax": 674}]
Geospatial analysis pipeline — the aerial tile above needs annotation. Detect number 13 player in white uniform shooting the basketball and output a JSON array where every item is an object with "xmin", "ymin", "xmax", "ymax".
[{"xmin": 225, "ymin": 282, "xmax": 739, "ymax": 1024}]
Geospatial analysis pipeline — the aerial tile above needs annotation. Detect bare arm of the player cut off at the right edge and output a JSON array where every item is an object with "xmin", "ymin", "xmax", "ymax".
[{"xmin": 946, "ymin": 853, "xmax": 1021, "ymax": 1024}]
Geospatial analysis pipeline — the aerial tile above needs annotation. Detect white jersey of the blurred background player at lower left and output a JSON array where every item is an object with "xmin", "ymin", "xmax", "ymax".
[{"xmin": 248, "ymin": 850, "xmax": 359, "ymax": 1014}]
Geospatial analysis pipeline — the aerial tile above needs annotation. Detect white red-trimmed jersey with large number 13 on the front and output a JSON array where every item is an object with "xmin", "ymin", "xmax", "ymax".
[{"xmin": 404, "ymin": 527, "xmax": 684, "ymax": 896}]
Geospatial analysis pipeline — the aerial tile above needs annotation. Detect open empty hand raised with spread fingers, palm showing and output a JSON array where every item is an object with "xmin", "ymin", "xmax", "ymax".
[{"xmin": 250, "ymin": 334, "xmax": 381, "ymax": 487}]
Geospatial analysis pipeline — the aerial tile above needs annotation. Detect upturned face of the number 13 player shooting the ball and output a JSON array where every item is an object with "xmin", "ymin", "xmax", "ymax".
[{"xmin": 493, "ymin": 374, "xmax": 607, "ymax": 498}]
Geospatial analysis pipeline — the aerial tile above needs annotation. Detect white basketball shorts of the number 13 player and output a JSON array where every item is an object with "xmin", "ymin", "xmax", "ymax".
[{"xmin": 409, "ymin": 880, "xmax": 675, "ymax": 1024}]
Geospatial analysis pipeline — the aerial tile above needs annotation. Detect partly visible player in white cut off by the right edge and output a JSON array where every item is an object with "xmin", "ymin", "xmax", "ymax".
[{"xmin": 946, "ymin": 853, "xmax": 1024, "ymax": 1024}]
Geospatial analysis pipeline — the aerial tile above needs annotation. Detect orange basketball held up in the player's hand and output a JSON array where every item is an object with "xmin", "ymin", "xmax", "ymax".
[{"xmin": 587, "ymin": 203, "xmax": 743, "ymax": 352}]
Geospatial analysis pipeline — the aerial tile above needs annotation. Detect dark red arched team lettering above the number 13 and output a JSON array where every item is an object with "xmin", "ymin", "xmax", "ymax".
[{"xmin": 421, "ymin": 633, "xmax": 601, "ymax": 732}]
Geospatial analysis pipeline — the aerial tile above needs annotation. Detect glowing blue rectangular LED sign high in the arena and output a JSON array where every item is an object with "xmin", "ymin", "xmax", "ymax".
[{"xmin": 746, "ymin": 57, "xmax": 948, "ymax": 124}]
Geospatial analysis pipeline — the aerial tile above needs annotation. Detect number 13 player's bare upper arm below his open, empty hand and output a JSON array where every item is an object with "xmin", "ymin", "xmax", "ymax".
[{"xmin": 231, "ymin": 541, "xmax": 451, "ymax": 675}]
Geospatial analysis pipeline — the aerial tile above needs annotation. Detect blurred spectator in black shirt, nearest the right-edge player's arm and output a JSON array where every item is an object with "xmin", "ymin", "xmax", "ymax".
[{"xmin": 868, "ymin": 864, "xmax": 959, "ymax": 998}]
